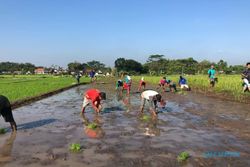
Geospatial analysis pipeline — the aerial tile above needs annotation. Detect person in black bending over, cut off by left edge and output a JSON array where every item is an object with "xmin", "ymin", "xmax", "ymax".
[{"xmin": 0, "ymin": 95, "xmax": 17, "ymax": 131}]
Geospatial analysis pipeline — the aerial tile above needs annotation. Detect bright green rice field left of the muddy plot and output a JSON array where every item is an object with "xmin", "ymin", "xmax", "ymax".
[{"xmin": 0, "ymin": 75, "xmax": 90, "ymax": 102}]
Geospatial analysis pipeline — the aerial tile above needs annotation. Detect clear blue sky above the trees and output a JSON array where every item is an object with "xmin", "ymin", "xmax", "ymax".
[{"xmin": 0, "ymin": 0, "xmax": 250, "ymax": 67}]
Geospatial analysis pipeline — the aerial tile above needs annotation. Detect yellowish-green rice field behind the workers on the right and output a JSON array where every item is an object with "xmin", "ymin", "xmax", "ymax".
[{"xmin": 133, "ymin": 75, "xmax": 250, "ymax": 101}]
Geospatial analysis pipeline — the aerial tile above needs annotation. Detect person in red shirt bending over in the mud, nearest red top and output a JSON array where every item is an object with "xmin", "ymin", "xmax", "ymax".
[{"xmin": 82, "ymin": 89, "xmax": 106, "ymax": 113}]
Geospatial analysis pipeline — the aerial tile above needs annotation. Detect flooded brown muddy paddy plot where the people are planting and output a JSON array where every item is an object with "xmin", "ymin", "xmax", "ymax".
[{"xmin": 0, "ymin": 81, "xmax": 250, "ymax": 167}]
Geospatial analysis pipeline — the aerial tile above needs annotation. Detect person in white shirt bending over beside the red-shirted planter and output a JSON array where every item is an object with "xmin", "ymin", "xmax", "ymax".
[{"xmin": 140, "ymin": 90, "xmax": 166, "ymax": 116}]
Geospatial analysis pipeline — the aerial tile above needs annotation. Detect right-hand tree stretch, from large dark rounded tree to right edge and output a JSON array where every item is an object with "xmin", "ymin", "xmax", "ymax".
[{"xmin": 115, "ymin": 55, "xmax": 245, "ymax": 75}]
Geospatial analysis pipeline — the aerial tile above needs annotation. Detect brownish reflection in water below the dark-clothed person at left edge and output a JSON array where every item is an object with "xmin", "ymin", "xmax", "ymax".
[{"xmin": 0, "ymin": 132, "xmax": 16, "ymax": 164}]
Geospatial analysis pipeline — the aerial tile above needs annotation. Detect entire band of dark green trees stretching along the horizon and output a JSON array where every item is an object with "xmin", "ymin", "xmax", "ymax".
[{"xmin": 0, "ymin": 54, "xmax": 245, "ymax": 75}]
